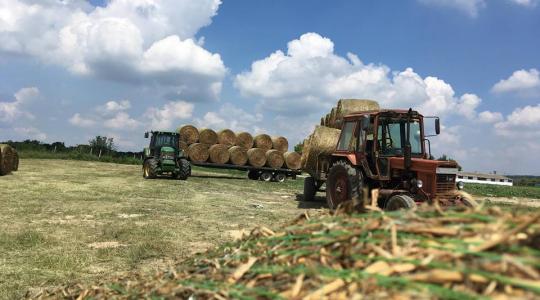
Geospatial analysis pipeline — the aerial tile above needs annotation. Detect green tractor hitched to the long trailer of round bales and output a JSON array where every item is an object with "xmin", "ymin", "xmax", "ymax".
[{"xmin": 143, "ymin": 131, "xmax": 191, "ymax": 180}]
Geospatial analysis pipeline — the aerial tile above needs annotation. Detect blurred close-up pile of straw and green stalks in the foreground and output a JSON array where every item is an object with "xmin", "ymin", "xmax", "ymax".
[{"xmin": 36, "ymin": 207, "xmax": 540, "ymax": 299}]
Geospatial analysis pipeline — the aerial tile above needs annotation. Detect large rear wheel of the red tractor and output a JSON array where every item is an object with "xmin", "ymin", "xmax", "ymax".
[{"xmin": 326, "ymin": 160, "xmax": 364, "ymax": 209}]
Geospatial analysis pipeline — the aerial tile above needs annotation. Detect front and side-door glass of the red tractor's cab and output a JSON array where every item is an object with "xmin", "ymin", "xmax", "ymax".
[{"xmin": 377, "ymin": 118, "xmax": 422, "ymax": 156}]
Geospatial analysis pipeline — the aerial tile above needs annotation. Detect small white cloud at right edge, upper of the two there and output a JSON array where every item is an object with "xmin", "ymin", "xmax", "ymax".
[{"xmin": 492, "ymin": 69, "xmax": 540, "ymax": 96}]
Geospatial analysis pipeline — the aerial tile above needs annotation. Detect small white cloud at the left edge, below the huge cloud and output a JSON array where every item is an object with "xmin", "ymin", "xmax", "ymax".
[{"xmin": 0, "ymin": 87, "xmax": 39, "ymax": 122}]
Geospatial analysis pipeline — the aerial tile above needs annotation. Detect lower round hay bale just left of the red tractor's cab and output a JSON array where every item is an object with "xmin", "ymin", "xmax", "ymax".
[{"xmin": 302, "ymin": 126, "xmax": 341, "ymax": 171}]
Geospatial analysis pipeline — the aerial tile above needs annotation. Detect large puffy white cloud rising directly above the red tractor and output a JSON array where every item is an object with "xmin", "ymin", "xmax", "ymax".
[{"xmin": 235, "ymin": 33, "xmax": 481, "ymax": 117}]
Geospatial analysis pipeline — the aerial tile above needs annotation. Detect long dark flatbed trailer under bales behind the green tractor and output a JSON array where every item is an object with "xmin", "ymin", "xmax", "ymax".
[{"xmin": 191, "ymin": 161, "xmax": 302, "ymax": 182}]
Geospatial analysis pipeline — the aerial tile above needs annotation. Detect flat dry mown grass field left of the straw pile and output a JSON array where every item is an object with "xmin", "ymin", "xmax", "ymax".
[{"xmin": 0, "ymin": 159, "xmax": 531, "ymax": 299}]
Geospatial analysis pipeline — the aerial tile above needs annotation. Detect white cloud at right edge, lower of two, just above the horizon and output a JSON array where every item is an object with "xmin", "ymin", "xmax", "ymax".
[{"xmin": 495, "ymin": 104, "xmax": 540, "ymax": 136}]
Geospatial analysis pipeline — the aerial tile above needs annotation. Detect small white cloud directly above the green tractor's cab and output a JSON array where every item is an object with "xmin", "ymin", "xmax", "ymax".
[{"xmin": 145, "ymin": 101, "xmax": 194, "ymax": 130}]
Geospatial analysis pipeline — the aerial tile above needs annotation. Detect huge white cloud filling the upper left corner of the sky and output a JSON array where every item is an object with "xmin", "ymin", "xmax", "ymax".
[{"xmin": 0, "ymin": 0, "xmax": 226, "ymax": 100}]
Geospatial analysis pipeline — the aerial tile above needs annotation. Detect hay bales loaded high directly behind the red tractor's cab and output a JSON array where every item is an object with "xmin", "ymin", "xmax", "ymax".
[{"xmin": 301, "ymin": 99, "xmax": 380, "ymax": 172}]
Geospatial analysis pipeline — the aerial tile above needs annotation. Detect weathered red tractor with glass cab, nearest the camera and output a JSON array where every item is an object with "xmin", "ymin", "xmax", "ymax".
[{"xmin": 304, "ymin": 109, "xmax": 476, "ymax": 210}]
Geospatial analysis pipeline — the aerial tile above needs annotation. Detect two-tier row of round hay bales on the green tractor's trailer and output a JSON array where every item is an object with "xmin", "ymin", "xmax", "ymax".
[{"xmin": 177, "ymin": 125, "xmax": 301, "ymax": 170}]
